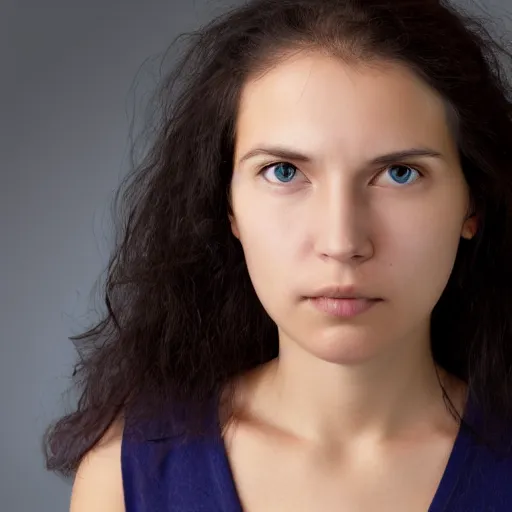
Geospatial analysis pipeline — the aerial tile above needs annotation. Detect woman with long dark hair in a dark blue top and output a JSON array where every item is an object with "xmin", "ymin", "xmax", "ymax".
[{"xmin": 47, "ymin": 0, "xmax": 512, "ymax": 512}]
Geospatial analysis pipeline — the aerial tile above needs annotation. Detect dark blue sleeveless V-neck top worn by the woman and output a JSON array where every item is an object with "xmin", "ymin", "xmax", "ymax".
[{"xmin": 121, "ymin": 390, "xmax": 512, "ymax": 512}]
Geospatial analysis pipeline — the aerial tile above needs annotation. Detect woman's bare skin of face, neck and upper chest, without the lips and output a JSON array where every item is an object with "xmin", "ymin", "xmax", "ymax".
[{"xmin": 226, "ymin": 53, "xmax": 477, "ymax": 511}]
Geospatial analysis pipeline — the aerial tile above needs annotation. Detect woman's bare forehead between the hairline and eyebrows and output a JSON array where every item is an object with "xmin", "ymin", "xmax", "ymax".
[{"xmin": 236, "ymin": 53, "xmax": 451, "ymax": 160}]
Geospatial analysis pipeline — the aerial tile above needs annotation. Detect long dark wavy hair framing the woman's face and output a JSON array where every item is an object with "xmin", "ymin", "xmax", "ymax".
[{"xmin": 44, "ymin": 0, "xmax": 512, "ymax": 474}]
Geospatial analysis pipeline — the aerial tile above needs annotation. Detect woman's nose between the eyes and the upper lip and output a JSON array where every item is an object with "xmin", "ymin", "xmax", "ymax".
[{"xmin": 315, "ymin": 187, "xmax": 374, "ymax": 264}]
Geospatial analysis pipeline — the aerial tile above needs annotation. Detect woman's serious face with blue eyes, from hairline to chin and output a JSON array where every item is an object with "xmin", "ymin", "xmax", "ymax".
[{"xmin": 231, "ymin": 53, "xmax": 475, "ymax": 363}]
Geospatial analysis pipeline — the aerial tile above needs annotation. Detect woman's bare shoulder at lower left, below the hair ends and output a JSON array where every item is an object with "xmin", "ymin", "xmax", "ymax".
[{"xmin": 70, "ymin": 419, "xmax": 125, "ymax": 512}]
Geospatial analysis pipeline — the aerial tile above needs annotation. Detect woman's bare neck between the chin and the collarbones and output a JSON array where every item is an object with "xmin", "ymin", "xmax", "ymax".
[{"xmin": 238, "ymin": 328, "xmax": 465, "ymax": 446}]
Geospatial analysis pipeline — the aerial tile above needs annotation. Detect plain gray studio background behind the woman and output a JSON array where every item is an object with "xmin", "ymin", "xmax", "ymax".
[{"xmin": 0, "ymin": 0, "xmax": 512, "ymax": 512}]
